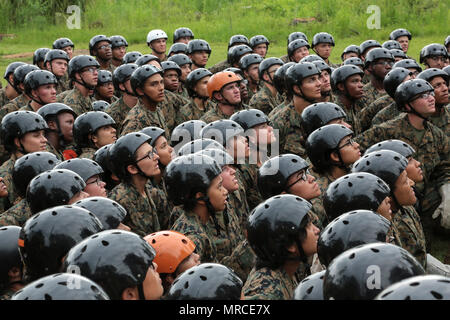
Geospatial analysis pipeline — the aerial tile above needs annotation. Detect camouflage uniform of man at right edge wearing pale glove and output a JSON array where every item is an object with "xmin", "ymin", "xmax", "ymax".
[{"xmin": 356, "ymin": 113, "xmax": 450, "ymax": 221}]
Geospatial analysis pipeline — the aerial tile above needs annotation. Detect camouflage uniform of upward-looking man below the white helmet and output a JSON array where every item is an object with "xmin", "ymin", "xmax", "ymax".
[{"xmin": 121, "ymin": 99, "xmax": 170, "ymax": 137}]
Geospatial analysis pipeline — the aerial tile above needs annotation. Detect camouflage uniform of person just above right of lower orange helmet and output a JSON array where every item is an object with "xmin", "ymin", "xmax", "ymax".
[{"xmin": 172, "ymin": 207, "xmax": 254, "ymax": 279}]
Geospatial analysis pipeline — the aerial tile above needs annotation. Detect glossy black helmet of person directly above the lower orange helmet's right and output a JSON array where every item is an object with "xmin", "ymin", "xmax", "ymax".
[{"xmin": 164, "ymin": 154, "xmax": 222, "ymax": 205}]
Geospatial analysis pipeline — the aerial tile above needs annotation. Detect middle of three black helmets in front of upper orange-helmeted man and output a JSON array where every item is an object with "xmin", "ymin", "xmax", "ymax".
[{"xmin": 200, "ymin": 119, "xmax": 244, "ymax": 146}]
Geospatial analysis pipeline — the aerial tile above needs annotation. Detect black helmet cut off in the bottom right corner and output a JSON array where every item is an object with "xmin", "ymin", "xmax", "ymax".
[{"xmin": 375, "ymin": 274, "xmax": 450, "ymax": 300}]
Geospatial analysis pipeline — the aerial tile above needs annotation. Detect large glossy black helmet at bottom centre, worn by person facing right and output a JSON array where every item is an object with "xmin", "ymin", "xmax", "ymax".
[{"xmin": 247, "ymin": 195, "xmax": 312, "ymax": 267}]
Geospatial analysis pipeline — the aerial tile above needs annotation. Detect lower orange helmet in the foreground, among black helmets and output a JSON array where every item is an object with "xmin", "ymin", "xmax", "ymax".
[{"xmin": 144, "ymin": 230, "xmax": 195, "ymax": 273}]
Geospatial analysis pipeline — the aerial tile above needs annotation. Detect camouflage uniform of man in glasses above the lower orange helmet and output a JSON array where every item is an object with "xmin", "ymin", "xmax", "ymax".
[{"xmin": 108, "ymin": 182, "xmax": 161, "ymax": 237}]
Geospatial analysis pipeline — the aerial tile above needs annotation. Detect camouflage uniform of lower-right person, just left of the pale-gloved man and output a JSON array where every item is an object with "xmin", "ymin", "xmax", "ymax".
[{"xmin": 392, "ymin": 206, "xmax": 427, "ymax": 268}]
